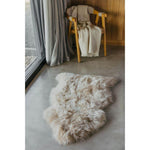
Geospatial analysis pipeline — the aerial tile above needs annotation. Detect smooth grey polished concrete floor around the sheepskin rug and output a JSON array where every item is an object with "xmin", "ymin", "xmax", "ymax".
[{"xmin": 26, "ymin": 47, "xmax": 125, "ymax": 150}]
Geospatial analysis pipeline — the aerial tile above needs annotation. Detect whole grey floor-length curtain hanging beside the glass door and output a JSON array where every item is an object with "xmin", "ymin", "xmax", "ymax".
[{"xmin": 31, "ymin": 0, "xmax": 74, "ymax": 66}]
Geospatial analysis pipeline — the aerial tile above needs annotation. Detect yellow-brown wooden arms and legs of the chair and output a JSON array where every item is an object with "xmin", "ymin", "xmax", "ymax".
[{"xmin": 67, "ymin": 10, "xmax": 107, "ymax": 63}]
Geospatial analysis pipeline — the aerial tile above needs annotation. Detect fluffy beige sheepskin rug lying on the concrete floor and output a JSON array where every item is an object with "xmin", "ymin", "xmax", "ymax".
[{"xmin": 44, "ymin": 73, "xmax": 117, "ymax": 145}]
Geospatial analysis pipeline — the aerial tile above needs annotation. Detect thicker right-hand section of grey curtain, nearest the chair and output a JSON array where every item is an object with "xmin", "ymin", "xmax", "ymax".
[{"xmin": 43, "ymin": 0, "xmax": 73, "ymax": 66}]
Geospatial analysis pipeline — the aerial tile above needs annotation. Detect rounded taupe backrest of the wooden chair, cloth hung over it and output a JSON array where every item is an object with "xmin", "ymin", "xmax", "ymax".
[{"xmin": 67, "ymin": 5, "xmax": 94, "ymax": 22}]
